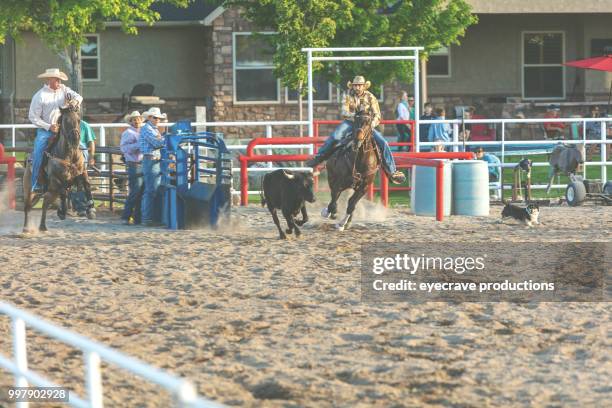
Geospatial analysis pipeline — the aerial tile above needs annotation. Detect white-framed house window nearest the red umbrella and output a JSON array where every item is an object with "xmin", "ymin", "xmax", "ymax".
[{"xmin": 523, "ymin": 32, "xmax": 565, "ymax": 99}]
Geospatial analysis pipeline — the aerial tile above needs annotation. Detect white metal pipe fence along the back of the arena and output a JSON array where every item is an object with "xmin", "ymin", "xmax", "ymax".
[{"xmin": 0, "ymin": 118, "xmax": 612, "ymax": 194}]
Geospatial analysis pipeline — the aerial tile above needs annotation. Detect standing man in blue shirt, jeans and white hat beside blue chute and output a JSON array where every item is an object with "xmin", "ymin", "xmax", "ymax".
[{"xmin": 139, "ymin": 107, "xmax": 167, "ymax": 226}]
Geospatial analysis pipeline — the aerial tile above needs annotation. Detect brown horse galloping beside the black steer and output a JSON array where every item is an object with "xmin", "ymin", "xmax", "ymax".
[{"xmin": 321, "ymin": 111, "xmax": 380, "ymax": 231}]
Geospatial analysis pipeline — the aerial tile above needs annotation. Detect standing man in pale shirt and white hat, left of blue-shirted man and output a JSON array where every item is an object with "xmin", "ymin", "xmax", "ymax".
[{"xmin": 120, "ymin": 111, "xmax": 143, "ymax": 225}]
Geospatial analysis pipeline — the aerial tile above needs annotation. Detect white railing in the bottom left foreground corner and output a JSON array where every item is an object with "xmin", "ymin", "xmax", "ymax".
[{"xmin": 0, "ymin": 302, "xmax": 222, "ymax": 408}]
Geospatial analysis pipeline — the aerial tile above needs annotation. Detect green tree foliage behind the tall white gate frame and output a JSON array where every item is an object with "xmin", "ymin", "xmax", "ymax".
[{"xmin": 224, "ymin": 0, "xmax": 477, "ymax": 89}]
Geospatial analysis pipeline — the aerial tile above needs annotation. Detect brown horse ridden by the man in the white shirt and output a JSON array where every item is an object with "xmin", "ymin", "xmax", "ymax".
[{"xmin": 23, "ymin": 108, "xmax": 94, "ymax": 232}]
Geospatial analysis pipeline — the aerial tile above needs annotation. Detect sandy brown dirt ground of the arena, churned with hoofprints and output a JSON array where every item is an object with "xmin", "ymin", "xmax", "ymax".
[{"xmin": 0, "ymin": 204, "xmax": 612, "ymax": 407}]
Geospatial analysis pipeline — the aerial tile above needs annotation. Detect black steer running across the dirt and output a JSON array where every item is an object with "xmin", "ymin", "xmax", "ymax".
[{"xmin": 261, "ymin": 170, "xmax": 315, "ymax": 239}]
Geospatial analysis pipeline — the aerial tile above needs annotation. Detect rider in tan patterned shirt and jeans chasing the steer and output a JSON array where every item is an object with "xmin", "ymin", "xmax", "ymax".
[{"xmin": 306, "ymin": 75, "xmax": 406, "ymax": 184}]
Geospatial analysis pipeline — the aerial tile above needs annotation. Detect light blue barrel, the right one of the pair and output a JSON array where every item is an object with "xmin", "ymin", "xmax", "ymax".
[{"xmin": 453, "ymin": 160, "xmax": 489, "ymax": 216}]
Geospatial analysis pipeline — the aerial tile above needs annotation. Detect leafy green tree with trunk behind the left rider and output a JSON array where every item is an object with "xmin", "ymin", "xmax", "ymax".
[{"xmin": 0, "ymin": 0, "xmax": 191, "ymax": 93}]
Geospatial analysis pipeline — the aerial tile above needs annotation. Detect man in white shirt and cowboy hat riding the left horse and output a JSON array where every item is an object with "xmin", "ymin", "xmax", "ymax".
[{"xmin": 28, "ymin": 68, "xmax": 83, "ymax": 192}]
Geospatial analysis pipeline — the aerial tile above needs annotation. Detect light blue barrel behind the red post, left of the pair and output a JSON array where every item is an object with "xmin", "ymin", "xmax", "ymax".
[{"xmin": 410, "ymin": 160, "xmax": 452, "ymax": 216}]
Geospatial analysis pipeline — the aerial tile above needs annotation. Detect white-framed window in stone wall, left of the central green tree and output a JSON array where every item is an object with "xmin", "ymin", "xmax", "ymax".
[{"xmin": 234, "ymin": 33, "xmax": 280, "ymax": 103}]
